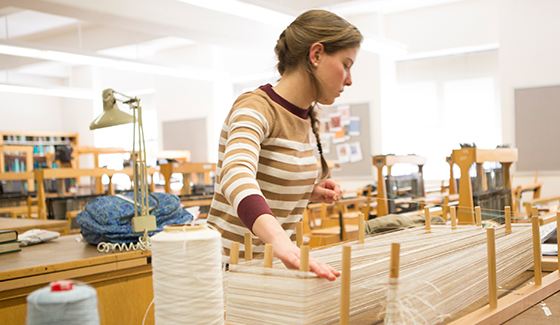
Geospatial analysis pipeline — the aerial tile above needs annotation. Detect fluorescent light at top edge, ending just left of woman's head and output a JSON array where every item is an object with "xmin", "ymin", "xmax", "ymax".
[{"xmin": 178, "ymin": 0, "xmax": 296, "ymax": 28}]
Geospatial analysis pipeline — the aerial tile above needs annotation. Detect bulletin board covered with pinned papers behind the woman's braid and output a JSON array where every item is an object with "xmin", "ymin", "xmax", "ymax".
[{"xmin": 319, "ymin": 103, "xmax": 373, "ymax": 178}]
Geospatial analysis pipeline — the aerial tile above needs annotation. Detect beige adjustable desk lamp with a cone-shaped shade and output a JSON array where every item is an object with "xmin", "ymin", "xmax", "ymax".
[{"xmin": 89, "ymin": 89, "xmax": 157, "ymax": 233}]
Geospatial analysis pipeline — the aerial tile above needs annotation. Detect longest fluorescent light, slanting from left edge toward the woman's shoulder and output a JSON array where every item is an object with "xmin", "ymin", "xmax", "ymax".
[{"xmin": 0, "ymin": 40, "xmax": 226, "ymax": 81}]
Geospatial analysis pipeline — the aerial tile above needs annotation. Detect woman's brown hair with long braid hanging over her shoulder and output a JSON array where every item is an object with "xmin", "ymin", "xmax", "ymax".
[{"xmin": 274, "ymin": 10, "xmax": 363, "ymax": 179}]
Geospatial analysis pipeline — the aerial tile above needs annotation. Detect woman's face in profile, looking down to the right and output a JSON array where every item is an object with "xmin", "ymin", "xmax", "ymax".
[{"xmin": 315, "ymin": 47, "xmax": 359, "ymax": 105}]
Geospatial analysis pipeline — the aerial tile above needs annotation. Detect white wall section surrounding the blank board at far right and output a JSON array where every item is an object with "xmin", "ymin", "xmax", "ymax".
[{"xmin": 499, "ymin": 0, "xmax": 560, "ymax": 197}]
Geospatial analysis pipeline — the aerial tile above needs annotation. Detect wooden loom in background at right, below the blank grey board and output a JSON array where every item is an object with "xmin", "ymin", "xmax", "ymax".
[{"xmin": 451, "ymin": 147, "xmax": 517, "ymax": 224}]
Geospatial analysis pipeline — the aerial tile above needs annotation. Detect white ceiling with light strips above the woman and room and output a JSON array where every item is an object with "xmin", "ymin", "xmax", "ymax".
[{"xmin": 0, "ymin": 0, "xmax": 470, "ymax": 93}]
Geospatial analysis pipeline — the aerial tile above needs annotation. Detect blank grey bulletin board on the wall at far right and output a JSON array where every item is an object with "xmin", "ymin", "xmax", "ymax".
[{"xmin": 515, "ymin": 85, "xmax": 560, "ymax": 172}]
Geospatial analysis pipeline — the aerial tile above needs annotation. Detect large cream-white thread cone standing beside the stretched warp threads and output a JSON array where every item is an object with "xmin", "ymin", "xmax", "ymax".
[{"xmin": 151, "ymin": 225, "xmax": 224, "ymax": 325}]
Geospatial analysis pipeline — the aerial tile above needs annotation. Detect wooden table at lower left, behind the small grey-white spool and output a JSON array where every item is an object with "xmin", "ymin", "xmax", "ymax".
[{"xmin": 0, "ymin": 235, "xmax": 154, "ymax": 325}]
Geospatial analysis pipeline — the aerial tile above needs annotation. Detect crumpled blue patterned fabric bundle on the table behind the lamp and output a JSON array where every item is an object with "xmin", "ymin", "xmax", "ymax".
[{"xmin": 76, "ymin": 192, "xmax": 193, "ymax": 245}]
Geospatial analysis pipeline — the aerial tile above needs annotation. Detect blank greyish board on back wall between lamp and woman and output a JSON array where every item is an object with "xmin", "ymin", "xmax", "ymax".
[{"xmin": 162, "ymin": 118, "xmax": 208, "ymax": 162}]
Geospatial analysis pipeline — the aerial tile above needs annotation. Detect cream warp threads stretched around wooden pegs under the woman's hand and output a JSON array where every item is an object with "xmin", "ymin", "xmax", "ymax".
[{"xmin": 226, "ymin": 207, "xmax": 558, "ymax": 324}]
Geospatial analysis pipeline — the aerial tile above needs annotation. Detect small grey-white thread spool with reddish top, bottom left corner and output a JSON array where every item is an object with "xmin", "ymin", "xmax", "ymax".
[{"xmin": 27, "ymin": 280, "xmax": 99, "ymax": 325}]
